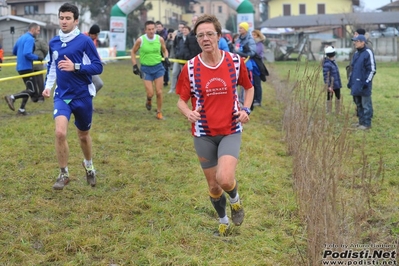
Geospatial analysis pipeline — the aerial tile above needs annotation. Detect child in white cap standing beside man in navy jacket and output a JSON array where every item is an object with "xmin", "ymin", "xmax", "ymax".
[{"xmin": 323, "ymin": 46, "xmax": 342, "ymax": 115}]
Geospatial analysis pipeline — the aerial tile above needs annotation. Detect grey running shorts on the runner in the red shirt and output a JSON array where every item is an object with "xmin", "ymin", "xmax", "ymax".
[{"xmin": 194, "ymin": 132, "xmax": 241, "ymax": 169}]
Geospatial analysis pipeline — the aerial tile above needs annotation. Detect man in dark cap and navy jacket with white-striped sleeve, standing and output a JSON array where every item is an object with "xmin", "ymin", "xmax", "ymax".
[{"xmin": 348, "ymin": 35, "xmax": 376, "ymax": 130}]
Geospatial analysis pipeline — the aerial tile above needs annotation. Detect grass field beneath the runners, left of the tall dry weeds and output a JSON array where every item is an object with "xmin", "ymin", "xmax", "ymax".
[{"xmin": 0, "ymin": 61, "xmax": 306, "ymax": 265}]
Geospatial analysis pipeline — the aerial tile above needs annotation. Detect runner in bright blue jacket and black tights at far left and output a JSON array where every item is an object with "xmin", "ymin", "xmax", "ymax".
[{"xmin": 4, "ymin": 23, "xmax": 43, "ymax": 115}]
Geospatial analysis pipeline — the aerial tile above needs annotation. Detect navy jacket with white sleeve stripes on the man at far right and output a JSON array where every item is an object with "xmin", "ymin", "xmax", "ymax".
[{"xmin": 348, "ymin": 46, "xmax": 376, "ymax": 96}]
